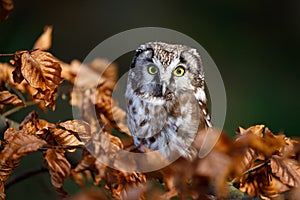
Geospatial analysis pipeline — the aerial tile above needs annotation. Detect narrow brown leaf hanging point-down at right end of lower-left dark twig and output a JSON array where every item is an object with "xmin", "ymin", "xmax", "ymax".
[{"xmin": 44, "ymin": 149, "xmax": 71, "ymax": 195}]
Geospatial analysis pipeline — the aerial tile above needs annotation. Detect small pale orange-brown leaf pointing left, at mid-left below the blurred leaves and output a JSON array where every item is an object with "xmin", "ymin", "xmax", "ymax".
[{"xmin": 59, "ymin": 120, "xmax": 91, "ymax": 143}]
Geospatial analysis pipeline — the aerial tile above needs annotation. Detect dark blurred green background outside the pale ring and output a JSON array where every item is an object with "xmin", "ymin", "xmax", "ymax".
[{"xmin": 0, "ymin": 0, "xmax": 300, "ymax": 200}]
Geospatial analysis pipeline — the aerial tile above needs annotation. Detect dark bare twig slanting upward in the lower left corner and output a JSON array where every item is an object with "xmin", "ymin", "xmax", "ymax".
[{"xmin": 5, "ymin": 167, "xmax": 48, "ymax": 189}]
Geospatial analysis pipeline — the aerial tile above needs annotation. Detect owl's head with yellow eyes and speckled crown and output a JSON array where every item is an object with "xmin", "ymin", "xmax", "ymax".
[{"xmin": 128, "ymin": 42, "xmax": 204, "ymax": 99}]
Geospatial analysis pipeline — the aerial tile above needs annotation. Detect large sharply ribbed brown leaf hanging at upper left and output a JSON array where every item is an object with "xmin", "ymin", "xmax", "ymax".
[{"xmin": 11, "ymin": 50, "xmax": 63, "ymax": 109}]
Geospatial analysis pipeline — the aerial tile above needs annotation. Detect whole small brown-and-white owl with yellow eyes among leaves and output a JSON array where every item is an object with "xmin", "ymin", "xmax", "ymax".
[{"xmin": 125, "ymin": 42, "xmax": 211, "ymax": 158}]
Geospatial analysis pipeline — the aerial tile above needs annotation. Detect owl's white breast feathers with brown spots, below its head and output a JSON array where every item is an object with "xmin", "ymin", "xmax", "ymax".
[{"xmin": 128, "ymin": 88, "xmax": 206, "ymax": 159}]
